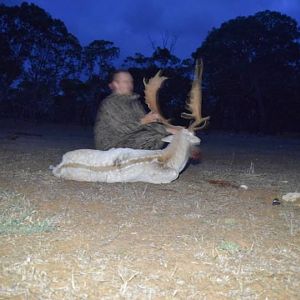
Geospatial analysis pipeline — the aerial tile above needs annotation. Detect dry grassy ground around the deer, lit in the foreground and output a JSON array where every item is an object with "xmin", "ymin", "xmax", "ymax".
[{"xmin": 0, "ymin": 121, "xmax": 300, "ymax": 300}]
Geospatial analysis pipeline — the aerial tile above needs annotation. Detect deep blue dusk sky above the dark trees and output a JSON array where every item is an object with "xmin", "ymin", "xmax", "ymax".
[{"xmin": 0, "ymin": 0, "xmax": 300, "ymax": 59}]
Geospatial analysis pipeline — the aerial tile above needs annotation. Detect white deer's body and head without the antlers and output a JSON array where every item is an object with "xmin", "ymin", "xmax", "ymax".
[{"xmin": 53, "ymin": 129, "xmax": 200, "ymax": 184}]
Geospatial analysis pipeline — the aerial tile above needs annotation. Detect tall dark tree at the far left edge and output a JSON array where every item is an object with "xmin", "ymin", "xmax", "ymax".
[{"xmin": 0, "ymin": 2, "xmax": 81, "ymax": 117}]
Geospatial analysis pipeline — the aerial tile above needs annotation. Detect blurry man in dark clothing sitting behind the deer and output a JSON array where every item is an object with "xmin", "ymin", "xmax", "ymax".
[{"xmin": 94, "ymin": 70, "xmax": 176, "ymax": 150}]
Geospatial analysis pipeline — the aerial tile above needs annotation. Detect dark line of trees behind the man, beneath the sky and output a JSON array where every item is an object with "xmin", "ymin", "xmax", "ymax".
[{"xmin": 0, "ymin": 2, "xmax": 300, "ymax": 133}]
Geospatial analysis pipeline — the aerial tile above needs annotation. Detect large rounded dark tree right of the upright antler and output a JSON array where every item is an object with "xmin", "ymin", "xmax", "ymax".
[{"xmin": 193, "ymin": 11, "xmax": 300, "ymax": 132}]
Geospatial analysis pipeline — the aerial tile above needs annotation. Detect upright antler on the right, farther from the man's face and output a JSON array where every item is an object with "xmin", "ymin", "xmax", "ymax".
[{"xmin": 181, "ymin": 59, "xmax": 210, "ymax": 131}]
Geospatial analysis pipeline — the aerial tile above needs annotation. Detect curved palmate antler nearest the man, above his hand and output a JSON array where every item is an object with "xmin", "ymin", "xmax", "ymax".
[{"xmin": 143, "ymin": 70, "xmax": 168, "ymax": 123}]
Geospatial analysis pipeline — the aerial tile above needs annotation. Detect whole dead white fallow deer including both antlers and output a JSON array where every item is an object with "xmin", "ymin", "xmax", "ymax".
[{"xmin": 53, "ymin": 61, "xmax": 209, "ymax": 184}]
